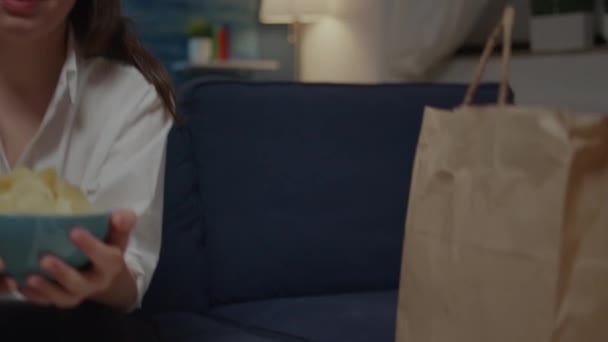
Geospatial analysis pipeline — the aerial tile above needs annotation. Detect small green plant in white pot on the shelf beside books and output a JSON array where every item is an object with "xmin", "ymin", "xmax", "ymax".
[{"xmin": 187, "ymin": 18, "xmax": 213, "ymax": 64}]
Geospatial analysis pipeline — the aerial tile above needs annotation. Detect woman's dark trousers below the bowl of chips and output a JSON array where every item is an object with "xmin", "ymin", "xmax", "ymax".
[{"xmin": 0, "ymin": 302, "xmax": 161, "ymax": 342}]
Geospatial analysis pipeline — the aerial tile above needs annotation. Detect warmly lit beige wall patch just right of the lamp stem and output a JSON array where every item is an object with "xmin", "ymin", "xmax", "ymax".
[{"xmin": 301, "ymin": 0, "xmax": 389, "ymax": 83}]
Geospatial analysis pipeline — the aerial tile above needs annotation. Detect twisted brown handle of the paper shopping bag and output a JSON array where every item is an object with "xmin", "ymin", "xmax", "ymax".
[{"xmin": 464, "ymin": 4, "xmax": 515, "ymax": 106}]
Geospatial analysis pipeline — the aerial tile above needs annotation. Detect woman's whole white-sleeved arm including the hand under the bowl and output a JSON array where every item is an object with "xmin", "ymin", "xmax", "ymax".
[{"xmin": 22, "ymin": 86, "xmax": 173, "ymax": 311}]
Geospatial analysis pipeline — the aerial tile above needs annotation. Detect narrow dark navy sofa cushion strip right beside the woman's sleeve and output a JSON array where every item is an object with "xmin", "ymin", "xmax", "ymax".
[{"xmin": 143, "ymin": 125, "xmax": 209, "ymax": 313}]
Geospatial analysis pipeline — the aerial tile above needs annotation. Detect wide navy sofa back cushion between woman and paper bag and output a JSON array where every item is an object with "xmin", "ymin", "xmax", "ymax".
[{"xmin": 175, "ymin": 82, "xmax": 508, "ymax": 305}]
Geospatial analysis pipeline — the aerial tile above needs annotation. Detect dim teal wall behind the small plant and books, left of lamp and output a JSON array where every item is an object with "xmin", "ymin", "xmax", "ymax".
[{"xmin": 122, "ymin": 0, "xmax": 293, "ymax": 83}]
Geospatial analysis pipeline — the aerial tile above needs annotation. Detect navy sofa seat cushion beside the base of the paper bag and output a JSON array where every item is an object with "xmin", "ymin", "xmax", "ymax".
[{"xmin": 210, "ymin": 291, "xmax": 397, "ymax": 342}]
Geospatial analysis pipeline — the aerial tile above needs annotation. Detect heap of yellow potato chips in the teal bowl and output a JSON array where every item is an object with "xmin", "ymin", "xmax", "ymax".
[{"xmin": 0, "ymin": 168, "xmax": 96, "ymax": 214}]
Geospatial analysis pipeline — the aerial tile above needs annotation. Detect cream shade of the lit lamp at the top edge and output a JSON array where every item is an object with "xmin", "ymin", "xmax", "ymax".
[{"xmin": 260, "ymin": 0, "xmax": 329, "ymax": 24}]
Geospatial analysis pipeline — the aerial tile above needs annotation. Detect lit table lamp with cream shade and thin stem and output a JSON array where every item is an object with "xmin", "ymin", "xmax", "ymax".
[{"xmin": 260, "ymin": 0, "xmax": 329, "ymax": 80}]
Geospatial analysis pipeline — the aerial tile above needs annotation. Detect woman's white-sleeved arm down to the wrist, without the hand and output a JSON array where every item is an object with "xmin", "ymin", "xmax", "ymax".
[{"xmin": 85, "ymin": 87, "xmax": 173, "ymax": 310}]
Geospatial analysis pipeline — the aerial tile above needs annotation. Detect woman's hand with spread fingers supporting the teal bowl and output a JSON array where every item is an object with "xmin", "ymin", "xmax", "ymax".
[{"xmin": 20, "ymin": 210, "xmax": 137, "ymax": 308}]
